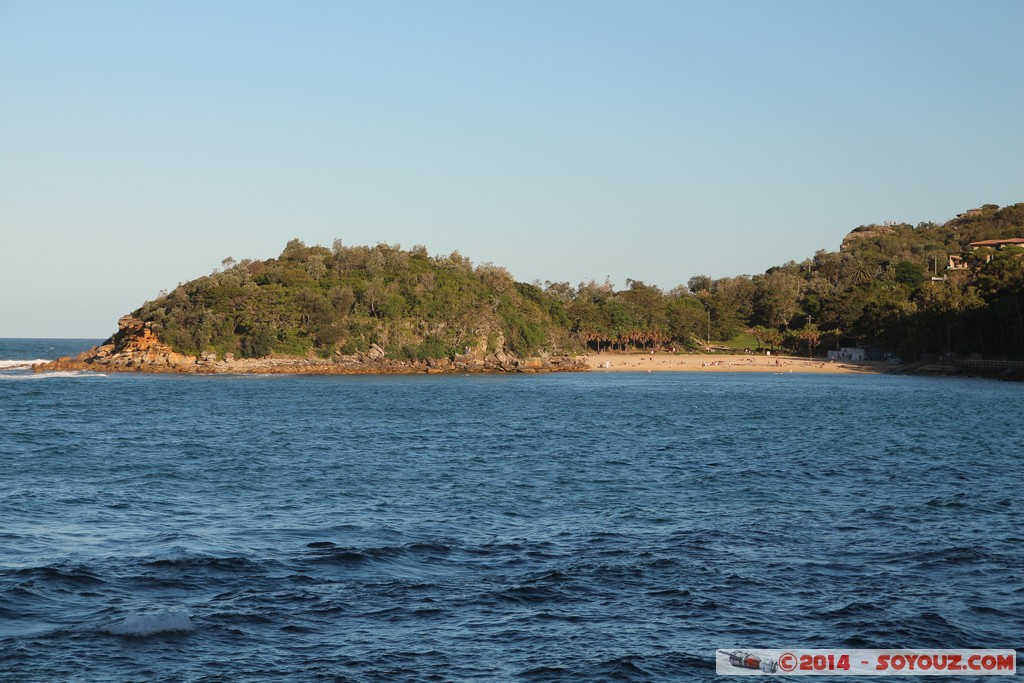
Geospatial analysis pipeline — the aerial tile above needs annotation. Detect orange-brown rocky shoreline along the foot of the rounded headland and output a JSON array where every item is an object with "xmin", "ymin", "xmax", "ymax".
[{"xmin": 32, "ymin": 315, "xmax": 587, "ymax": 375}]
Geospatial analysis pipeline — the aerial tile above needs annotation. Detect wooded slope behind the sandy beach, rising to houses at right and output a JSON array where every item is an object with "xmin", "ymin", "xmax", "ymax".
[{"xmin": 546, "ymin": 204, "xmax": 1024, "ymax": 360}]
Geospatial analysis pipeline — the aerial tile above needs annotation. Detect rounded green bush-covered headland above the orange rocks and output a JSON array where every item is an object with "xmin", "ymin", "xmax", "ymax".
[{"xmin": 133, "ymin": 240, "xmax": 572, "ymax": 360}]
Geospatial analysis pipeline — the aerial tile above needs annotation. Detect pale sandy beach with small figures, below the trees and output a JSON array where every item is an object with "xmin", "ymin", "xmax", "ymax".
[{"xmin": 586, "ymin": 353, "xmax": 892, "ymax": 374}]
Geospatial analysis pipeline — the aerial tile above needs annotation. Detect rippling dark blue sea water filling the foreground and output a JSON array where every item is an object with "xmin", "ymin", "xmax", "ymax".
[{"xmin": 0, "ymin": 342, "xmax": 1024, "ymax": 682}]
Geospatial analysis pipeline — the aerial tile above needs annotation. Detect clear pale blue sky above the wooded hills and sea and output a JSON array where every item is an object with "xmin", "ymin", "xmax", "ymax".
[{"xmin": 0, "ymin": 0, "xmax": 1024, "ymax": 337}]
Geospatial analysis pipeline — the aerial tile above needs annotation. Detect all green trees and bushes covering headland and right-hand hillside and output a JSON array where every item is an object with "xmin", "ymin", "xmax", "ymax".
[{"xmin": 135, "ymin": 204, "xmax": 1024, "ymax": 360}]
